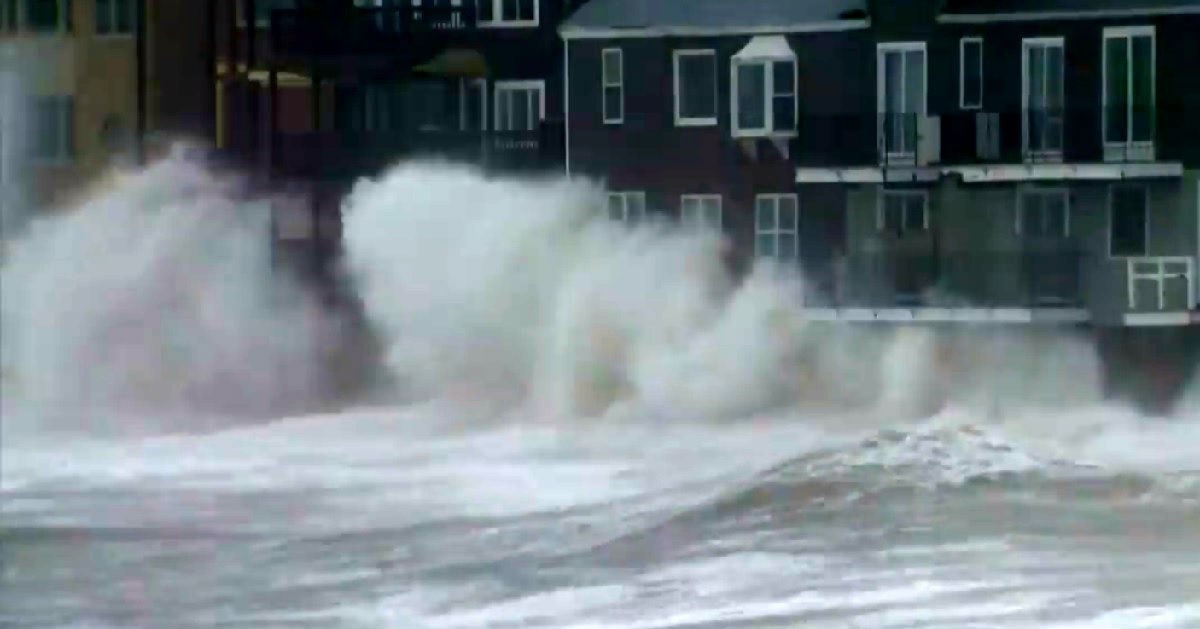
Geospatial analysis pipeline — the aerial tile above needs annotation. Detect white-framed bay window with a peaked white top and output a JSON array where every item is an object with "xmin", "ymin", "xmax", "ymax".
[{"xmin": 731, "ymin": 35, "xmax": 797, "ymax": 137}]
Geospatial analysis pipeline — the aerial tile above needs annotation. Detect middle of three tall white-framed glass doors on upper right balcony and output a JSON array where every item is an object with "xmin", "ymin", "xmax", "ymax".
[{"xmin": 1021, "ymin": 37, "xmax": 1063, "ymax": 156}]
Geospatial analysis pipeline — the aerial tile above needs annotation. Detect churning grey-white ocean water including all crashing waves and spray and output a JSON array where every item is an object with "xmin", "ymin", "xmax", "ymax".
[{"xmin": 0, "ymin": 158, "xmax": 1200, "ymax": 629}]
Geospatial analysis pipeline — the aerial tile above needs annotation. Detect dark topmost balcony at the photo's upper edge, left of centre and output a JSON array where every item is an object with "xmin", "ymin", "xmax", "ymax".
[{"xmin": 271, "ymin": 1, "xmax": 479, "ymax": 58}]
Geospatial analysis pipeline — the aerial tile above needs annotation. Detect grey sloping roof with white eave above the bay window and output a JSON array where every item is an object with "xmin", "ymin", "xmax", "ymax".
[{"xmin": 562, "ymin": 0, "xmax": 868, "ymax": 37}]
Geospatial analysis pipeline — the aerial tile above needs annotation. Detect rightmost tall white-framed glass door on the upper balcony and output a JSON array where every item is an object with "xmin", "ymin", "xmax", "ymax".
[{"xmin": 1104, "ymin": 26, "xmax": 1154, "ymax": 158}]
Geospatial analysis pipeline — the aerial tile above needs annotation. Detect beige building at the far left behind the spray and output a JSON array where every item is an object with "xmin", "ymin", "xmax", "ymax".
[{"xmin": 0, "ymin": 0, "xmax": 138, "ymax": 208}]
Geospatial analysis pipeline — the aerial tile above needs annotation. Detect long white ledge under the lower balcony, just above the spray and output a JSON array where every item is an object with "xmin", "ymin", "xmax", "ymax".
[{"xmin": 800, "ymin": 307, "xmax": 1092, "ymax": 324}]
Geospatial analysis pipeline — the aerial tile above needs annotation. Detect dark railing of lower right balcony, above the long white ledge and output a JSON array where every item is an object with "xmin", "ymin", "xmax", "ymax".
[{"xmin": 808, "ymin": 251, "xmax": 1082, "ymax": 308}]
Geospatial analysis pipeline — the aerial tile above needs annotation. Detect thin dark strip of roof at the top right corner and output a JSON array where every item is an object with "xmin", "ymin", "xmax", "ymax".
[{"xmin": 942, "ymin": 0, "xmax": 1200, "ymax": 20}]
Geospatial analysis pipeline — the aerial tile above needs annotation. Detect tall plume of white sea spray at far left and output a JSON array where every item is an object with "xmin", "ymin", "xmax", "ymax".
[{"xmin": 0, "ymin": 156, "xmax": 323, "ymax": 432}]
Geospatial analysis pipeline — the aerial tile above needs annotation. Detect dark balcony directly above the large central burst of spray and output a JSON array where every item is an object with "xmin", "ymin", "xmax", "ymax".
[{"xmin": 271, "ymin": 122, "xmax": 563, "ymax": 179}]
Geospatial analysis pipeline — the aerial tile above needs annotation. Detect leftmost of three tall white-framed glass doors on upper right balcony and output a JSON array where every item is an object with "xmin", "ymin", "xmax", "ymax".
[{"xmin": 876, "ymin": 42, "xmax": 926, "ymax": 157}]
